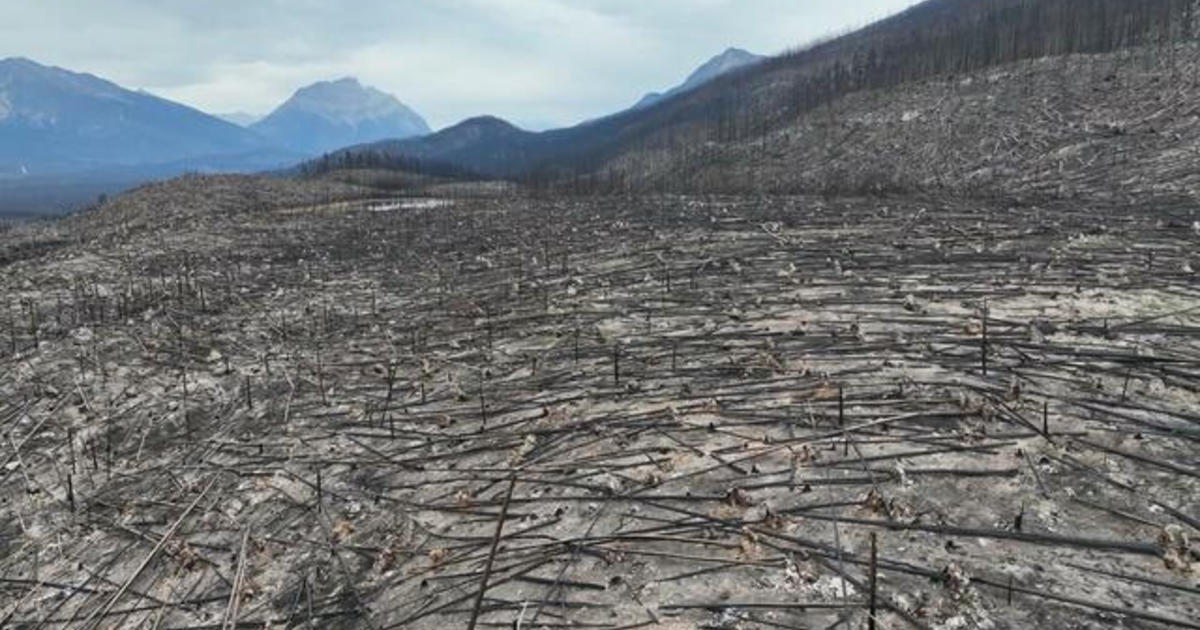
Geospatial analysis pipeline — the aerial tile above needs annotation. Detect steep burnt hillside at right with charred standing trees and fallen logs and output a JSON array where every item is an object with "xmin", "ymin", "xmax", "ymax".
[{"xmin": 594, "ymin": 0, "xmax": 1200, "ymax": 196}]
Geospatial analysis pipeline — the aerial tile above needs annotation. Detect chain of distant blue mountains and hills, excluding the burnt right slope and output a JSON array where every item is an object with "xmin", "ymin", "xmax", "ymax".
[{"xmin": 0, "ymin": 48, "xmax": 763, "ymax": 214}]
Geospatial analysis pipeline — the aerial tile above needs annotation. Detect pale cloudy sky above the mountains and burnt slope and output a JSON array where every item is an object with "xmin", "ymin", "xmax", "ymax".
[{"xmin": 0, "ymin": 0, "xmax": 914, "ymax": 130}]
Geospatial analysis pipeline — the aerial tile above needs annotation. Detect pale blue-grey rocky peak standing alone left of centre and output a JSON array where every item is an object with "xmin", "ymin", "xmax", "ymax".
[{"xmin": 251, "ymin": 77, "xmax": 431, "ymax": 155}]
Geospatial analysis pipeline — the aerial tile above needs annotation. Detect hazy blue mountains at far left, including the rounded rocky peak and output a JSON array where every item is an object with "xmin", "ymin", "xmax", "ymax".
[{"xmin": 0, "ymin": 58, "xmax": 441, "ymax": 215}]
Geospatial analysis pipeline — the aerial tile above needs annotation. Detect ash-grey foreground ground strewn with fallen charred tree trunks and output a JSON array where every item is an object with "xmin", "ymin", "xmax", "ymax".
[{"xmin": 0, "ymin": 179, "xmax": 1200, "ymax": 629}]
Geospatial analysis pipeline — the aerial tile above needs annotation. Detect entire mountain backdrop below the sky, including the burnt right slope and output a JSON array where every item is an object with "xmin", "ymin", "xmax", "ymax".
[{"xmin": 7, "ymin": 0, "xmax": 1180, "ymax": 216}]
